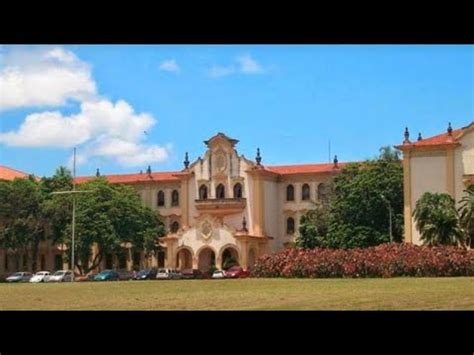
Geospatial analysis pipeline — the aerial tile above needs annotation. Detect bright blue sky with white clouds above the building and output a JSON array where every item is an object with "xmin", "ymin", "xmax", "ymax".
[{"xmin": 0, "ymin": 45, "xmax": 474, "ymax": 175}]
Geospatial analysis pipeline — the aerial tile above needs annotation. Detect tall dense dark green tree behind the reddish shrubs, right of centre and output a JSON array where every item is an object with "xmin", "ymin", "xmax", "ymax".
[{"xmin": 325, "ymin": 160, "xmax": 403, "ymax": 248}]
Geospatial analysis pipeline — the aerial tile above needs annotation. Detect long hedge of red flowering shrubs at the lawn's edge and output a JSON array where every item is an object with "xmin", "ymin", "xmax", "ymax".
[{"xmin": 253, "ymin": 243, "xmax": 473, "ymax": 277}]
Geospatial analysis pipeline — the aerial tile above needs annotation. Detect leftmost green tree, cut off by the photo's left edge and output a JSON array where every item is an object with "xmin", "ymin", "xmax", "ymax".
[{"xmin": 0, "ymin": 176, "xmax": 46, "ymax": 270}]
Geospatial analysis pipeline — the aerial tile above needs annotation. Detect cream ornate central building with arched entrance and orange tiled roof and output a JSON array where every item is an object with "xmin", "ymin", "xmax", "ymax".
[{"xmin": 0, "ymin": 133, "xmax": 345, "ymax": 273}]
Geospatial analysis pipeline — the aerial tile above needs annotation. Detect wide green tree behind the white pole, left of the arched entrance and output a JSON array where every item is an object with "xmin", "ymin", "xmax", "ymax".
[{"xmin": 49, "ymin": 177, "xmax": 164, "ymax": 273}]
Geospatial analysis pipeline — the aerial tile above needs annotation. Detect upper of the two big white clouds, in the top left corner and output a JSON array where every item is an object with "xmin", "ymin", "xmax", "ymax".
[{"xmin": 0, "ymin": 47, "xmax": 97, "ymax": 111}]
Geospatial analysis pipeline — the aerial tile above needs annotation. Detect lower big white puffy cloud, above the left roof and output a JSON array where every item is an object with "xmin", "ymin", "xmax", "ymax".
[{"xmin": 0, "ymin": 100, "xmax": 169, "ymax": 166}]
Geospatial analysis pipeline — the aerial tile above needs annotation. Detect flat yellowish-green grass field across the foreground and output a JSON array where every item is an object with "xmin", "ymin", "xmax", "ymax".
[{"xmin": 0, "ymin": 277, "xmax": 474, "ymax": 310}]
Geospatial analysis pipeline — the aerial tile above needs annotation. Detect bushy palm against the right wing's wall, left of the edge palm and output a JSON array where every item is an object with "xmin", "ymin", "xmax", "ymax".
[{"xmin": 413, "ymin": 192, "xmax": 465, "ymax": 246}]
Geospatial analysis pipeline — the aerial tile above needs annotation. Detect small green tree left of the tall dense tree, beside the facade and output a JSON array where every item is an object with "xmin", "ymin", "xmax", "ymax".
[{"xmin": 295, "ymin": 206, "xmax": 329, "ymax": 249}]
